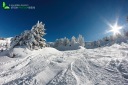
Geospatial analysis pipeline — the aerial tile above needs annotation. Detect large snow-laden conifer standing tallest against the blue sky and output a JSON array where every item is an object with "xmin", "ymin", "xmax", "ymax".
[{"xmin": 11, "ymin": 21, "xmax": 46, "ymax": 50}]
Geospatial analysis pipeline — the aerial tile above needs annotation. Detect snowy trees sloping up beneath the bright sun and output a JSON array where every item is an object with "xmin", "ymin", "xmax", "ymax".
[{"xmin": 86, "ymin": 30, "xmax": 128, "ymax": 48}]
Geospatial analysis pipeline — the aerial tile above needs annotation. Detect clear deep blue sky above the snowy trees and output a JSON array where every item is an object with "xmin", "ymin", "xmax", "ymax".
[{"xmin": 0, "ymin": 0, "xmax": 128, "ymax": 41}]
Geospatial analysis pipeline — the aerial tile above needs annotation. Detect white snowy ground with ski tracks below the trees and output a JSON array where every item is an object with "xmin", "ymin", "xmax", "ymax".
[{"xmin": 0, "ymin": 43, "xmax": 128, "ymax": 85}]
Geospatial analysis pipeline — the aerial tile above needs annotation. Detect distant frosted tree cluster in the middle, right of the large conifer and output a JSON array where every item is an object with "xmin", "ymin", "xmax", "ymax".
[{"xmin": 54, "ymin": 35, "xmax": 85, "ymax": 47}]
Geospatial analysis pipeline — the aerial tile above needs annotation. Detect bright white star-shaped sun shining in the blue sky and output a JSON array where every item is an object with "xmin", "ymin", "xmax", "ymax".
[{"xmin": 108, "ymin": 21, "xmax": 123, "ymax": 35}]
